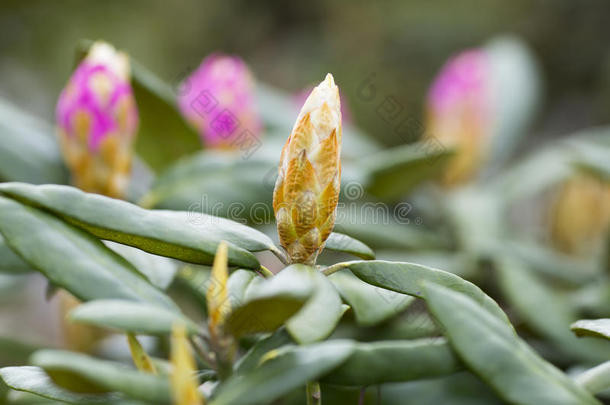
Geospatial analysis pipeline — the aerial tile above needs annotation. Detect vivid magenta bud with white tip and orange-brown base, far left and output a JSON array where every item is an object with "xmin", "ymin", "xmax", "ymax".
[{"xmin": 56, "ymin": 42, "xmax": 138, "ymax": 198}]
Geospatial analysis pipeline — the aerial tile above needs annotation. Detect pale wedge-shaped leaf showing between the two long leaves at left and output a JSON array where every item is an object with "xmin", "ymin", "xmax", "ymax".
[{"xmin": 105, "ymin": 241, "xmax": 178, "ymax": 290}]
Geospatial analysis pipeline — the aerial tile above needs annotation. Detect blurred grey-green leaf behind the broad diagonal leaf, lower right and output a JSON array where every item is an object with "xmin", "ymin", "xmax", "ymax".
[{"xmin": 497, "ymin": 259, "xmax": 610, "ymax": 362}]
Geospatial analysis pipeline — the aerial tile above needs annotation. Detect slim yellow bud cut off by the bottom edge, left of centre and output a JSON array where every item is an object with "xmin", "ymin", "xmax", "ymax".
[{"xmin": 170, "ymin": 325, "xmax": 205, "ymax": 405}]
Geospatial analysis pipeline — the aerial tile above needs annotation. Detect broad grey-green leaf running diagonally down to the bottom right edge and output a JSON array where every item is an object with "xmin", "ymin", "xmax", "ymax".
[{"xmin": 424, "ymin": 283, "xmax": 599, "ymax": 405}]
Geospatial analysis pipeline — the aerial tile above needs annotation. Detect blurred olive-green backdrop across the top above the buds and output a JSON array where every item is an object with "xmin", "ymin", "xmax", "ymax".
[{"xmin": 0, "ymin": 0, "xmax": 610, "ymax": 145}]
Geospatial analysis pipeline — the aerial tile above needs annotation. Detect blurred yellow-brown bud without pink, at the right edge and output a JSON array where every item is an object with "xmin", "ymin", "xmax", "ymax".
[{"xmin": 551, "ymin": 174, "xmax": 610, "ymax": 255}]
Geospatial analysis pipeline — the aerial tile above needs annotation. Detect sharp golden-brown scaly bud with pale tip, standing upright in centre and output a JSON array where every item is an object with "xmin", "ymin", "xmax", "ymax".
[{"xmin": 273, "ymin": 74, "xmax": 341, "ymax": 264}]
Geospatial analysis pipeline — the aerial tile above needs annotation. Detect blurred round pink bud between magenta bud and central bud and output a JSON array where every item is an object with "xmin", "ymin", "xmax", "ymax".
[{"xmin": 178, "ymin": 54, "xmax": 261, "ymax": 148}]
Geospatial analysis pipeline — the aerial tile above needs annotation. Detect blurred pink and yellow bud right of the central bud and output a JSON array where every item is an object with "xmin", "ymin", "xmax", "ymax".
[{"xmin": 425, "ymin": 50, "xmax": 492, "ymax": 186}]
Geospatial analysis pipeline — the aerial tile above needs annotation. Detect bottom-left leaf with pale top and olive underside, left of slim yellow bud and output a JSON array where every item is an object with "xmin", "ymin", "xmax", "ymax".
[{"xmin": 31, "ymin": 350, "xmax": 170, "ymax": 403}]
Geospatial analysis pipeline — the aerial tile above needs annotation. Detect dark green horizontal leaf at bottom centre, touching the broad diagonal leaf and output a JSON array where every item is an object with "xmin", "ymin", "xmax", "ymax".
[{"xmin": 322, "ymin": 338, "xmax": 462, "ymax": 386}]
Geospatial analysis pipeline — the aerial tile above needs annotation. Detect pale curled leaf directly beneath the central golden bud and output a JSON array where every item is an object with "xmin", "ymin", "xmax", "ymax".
[{"xmin": 284, "ymin": 264, "xmax": 344, "ymax": 344}]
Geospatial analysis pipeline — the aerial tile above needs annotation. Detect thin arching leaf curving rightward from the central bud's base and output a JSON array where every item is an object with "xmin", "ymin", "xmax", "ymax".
[{"xmin": 328, "ymin": 260, "xmax": 509, "ymax": 323}]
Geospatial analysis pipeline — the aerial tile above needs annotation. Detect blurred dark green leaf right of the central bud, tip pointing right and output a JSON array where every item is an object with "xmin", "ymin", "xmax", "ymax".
[{"xmin": 362, "ymin": 141, "xmax": 453, "ymax": 201}]
